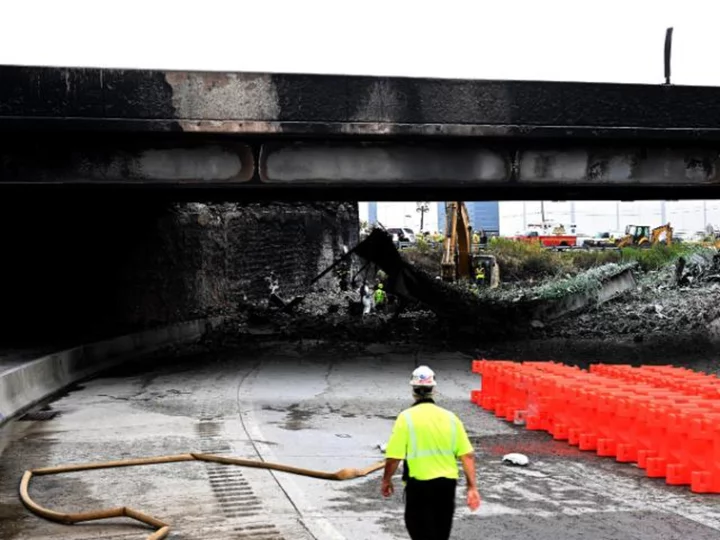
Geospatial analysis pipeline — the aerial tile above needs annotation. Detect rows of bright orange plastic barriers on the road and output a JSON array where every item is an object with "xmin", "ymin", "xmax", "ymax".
[{"xmin": 471, "ymin": 360, "xmax": 720, "ymax": 493}]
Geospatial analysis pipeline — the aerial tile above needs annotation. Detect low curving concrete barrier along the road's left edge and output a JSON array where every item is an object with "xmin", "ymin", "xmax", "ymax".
[{"xmin": 0, "ymin": 318, "xmax": 223, "ymax": 425}]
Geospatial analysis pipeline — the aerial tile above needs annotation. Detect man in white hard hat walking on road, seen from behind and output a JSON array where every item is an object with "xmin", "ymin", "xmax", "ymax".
[{"xmin": 381, "ymin": 366, "xmax": 480, "ymax": 540}]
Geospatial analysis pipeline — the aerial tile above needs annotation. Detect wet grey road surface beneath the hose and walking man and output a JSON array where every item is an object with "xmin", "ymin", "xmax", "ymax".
[{"xmin": 0, "ymin": 342, "xmax": 720, "ymax": 540}]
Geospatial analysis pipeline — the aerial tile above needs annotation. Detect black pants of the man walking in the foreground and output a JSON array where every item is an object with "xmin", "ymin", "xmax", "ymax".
[{"xmin": 405, "ymin": 478, "xmax": 457, "ymax": 540}]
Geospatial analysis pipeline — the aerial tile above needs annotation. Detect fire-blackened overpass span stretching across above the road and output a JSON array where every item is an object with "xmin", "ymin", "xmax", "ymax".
[{"xmin": 0, "ymin": 66, "xmax": 720, "ymax": 200}]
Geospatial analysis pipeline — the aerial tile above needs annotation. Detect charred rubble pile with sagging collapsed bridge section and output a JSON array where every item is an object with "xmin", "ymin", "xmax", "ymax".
[{"xmin": 217, "ymin": 229, "xmax": 720, "ymax": 348}]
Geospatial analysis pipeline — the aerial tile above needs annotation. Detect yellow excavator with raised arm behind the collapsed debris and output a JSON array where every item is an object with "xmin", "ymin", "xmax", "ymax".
[{"xmin": 441, "ymin": 201, "xmax": 500, "ymax": 289}]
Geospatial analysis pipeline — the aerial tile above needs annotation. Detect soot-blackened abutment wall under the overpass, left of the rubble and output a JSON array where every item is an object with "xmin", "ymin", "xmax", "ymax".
[{"xmin": 0, "ymin": 199, "xmax": 358, "ymax": 344}]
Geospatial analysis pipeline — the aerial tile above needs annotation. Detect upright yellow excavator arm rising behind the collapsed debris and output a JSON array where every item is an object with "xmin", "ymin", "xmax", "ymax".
[{"xmin": 441, "ymin": 201, "xmax": 472, "ymax": 281}]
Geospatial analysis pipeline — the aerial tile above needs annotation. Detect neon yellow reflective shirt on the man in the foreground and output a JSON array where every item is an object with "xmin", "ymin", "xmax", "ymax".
[{"xmin": 385, "ymin": 403, "xmax": 473, "ymax": 480}]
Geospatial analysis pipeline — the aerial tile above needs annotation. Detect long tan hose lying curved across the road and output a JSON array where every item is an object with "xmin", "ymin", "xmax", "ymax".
[{"xmin": 20, "ymin": 453, "xmax": 384, "ymax": 540}]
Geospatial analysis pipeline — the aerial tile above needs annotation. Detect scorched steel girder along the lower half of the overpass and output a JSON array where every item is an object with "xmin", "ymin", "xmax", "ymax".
[{"xmin": 0, "ymin": 137, "xmax": 720, "ymax": 192}]
